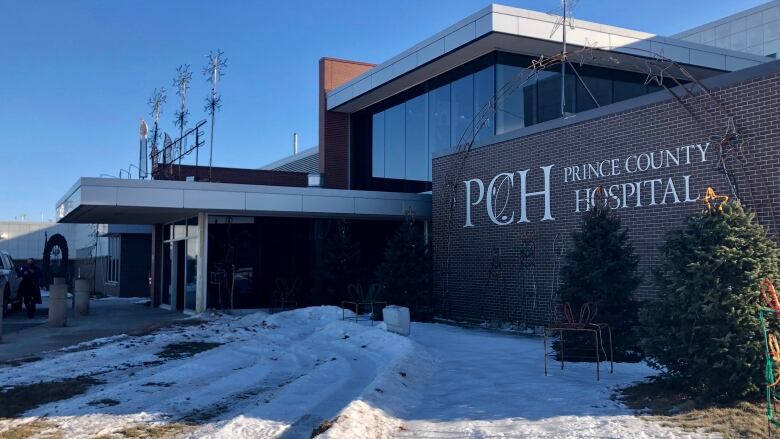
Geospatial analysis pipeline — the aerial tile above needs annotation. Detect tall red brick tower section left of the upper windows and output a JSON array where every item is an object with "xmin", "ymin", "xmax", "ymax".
[{"xmin": 319, "ymin": 58, "xmax": 374, "ymax": 189}]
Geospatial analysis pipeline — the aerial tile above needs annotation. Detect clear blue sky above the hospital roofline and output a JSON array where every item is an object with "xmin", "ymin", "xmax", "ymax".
[{"xmin": 0, "ymin": 0, "xmax": 763, "ymax": 220}]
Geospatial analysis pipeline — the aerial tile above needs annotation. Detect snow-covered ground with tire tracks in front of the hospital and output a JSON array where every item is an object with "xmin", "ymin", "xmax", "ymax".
[{"xmin": 0, "ymin": 307, "xmax": 708, "ymax": 438}]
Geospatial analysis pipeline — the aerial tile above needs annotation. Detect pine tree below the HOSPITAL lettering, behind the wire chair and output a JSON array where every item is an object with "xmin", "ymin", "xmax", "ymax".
[{"xmin": 554, "ymin": 191, "xmax": 641, "ymax": 361}]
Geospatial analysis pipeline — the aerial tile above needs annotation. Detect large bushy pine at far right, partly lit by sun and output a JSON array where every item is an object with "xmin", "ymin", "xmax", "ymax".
[{"xmin": 640, "ymin": 201, "xmax": 778, "ymax": 400}]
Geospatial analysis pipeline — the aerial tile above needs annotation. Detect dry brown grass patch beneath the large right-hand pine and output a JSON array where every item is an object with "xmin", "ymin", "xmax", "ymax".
[{"xmin": 618, "ymin": 379, "xmax": 776, "ymax": 439}]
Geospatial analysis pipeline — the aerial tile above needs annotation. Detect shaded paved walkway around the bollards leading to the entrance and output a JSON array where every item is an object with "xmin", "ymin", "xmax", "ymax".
[{"xmin": 0, "ymin": 298, "xmax": 187, "ymax": 362}]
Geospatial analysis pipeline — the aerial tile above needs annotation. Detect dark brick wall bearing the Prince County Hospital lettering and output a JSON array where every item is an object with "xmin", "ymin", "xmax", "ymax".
[{"xmin": 433, "ymin": 74, "xmax": 780, "ymax": 324}]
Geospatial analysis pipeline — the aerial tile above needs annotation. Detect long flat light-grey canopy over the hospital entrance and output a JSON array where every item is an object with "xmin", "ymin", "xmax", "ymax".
[{"xmin": 57, "ymin": 177, "xmax": 431, "ymax": 224}]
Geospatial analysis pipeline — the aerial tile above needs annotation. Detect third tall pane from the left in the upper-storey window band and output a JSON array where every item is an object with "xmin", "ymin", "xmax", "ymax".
[{"xmin": 406, "ymin": 94, "xmax": 429, "ymax": 181}]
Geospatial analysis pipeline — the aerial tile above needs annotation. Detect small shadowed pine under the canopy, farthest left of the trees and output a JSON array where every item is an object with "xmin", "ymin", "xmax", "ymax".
[{"xmin": 314, "ymin": 220, "xmax": 367, "ymax": 304}]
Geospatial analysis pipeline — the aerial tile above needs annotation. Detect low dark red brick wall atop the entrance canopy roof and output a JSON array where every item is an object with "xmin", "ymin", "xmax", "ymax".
[{"xmin": 155, "ymin": 165, "xmax": 309, "ymax": 187}]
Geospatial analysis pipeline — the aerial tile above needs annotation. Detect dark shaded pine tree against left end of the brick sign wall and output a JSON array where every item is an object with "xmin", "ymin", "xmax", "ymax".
[{"xmin": 376, "ymin": 214, "xmax": 433, "ymax": 321}]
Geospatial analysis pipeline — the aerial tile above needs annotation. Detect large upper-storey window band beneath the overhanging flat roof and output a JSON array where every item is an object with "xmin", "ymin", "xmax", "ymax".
[{"xmin": 362, "ymin": 52, "xmax": 680, "ymax": 187}]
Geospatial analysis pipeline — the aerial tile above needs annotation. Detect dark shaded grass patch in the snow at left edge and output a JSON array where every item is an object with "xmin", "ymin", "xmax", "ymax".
[{"xmin": 0, "ymin": 376, "xmax": 103, "ymax": 418}]
